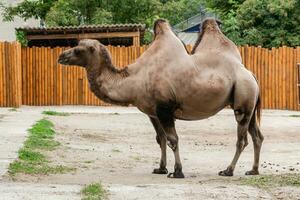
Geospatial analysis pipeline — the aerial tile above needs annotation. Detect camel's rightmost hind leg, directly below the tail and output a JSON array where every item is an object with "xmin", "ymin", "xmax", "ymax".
[{"xmin": 246, "ymin": 113, "xmax": 264, "ymax": 175}]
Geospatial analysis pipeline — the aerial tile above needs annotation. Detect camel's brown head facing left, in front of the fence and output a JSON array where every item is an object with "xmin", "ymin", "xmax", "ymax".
[{"xmin": 58, "ymin": 39, "xmax": 100, "ymax": 67}]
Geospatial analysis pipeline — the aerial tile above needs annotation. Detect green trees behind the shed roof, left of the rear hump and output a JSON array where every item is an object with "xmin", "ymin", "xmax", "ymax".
[{"xmin": 2, "ymin": 0, "xmax": 204, "ymax": 43}]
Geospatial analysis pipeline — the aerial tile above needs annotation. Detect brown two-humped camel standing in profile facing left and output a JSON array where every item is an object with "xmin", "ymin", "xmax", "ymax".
[{"xmin": 58, "ymin": 19, "xmax": 263, "ymax": 178}]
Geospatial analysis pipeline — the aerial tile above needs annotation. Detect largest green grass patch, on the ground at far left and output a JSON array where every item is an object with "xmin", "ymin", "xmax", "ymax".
[{"xmin": 8, "ymin": 119, "xmax": 74, "ymax": 175}]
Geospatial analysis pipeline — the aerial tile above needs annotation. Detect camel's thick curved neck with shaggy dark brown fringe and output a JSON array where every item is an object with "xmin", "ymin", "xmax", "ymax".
[{"xmin": 87, "ymin": 60, "xmax": 134, "ymax": 105}]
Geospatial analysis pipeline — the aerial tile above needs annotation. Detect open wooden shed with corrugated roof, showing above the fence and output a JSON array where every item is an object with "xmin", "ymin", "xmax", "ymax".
[{"xmin": 16, "ymin": 24, "xmax": 146, "ymax": 46}]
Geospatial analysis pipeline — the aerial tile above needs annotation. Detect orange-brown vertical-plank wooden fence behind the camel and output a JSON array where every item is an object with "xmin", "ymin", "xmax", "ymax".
[{"xmin": 0, "ymin": 43, "xmax": 300, "ymax": 110}]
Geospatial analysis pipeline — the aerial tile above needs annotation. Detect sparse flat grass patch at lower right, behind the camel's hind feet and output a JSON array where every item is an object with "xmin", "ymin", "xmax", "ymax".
[{"xmin": 241, "ymin": 174, "xmax": 300, "ymax": 188}]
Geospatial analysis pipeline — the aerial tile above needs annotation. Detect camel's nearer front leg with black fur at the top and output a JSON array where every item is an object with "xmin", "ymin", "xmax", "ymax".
[{"xmin": 157, "ymin": 106, "xmax": 184, "ymax": 178}]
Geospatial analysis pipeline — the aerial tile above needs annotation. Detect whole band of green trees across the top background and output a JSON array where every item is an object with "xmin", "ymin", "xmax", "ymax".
[{"xmin": 0, "ymin": 0, "xmax": 300, "ymax": 47}]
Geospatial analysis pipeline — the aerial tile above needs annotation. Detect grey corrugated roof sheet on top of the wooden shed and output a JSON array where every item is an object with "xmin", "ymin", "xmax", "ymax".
[{"xmin": 16, "ymin": 24, "xmax": 146, "ymax": 34}]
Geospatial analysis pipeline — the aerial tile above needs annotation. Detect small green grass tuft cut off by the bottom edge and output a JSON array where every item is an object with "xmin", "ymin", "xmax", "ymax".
[{"xmin": 81, "ymin": 183, "xmax": 106, "ymax": 200}]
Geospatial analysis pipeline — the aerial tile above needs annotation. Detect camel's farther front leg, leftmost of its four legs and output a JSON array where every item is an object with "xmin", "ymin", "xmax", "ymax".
[{"xmin": 150, "ymin": 117, "xmax": 168, "ymax": 174}]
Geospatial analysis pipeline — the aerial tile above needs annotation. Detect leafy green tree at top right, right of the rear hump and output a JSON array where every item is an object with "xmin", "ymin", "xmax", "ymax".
[{"xmin": 207, "ymin": 0, "xmax": 300, "ymax": 48}]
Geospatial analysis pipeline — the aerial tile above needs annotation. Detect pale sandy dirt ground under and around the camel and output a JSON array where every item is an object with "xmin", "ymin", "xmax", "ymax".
[{"xmin": 2, "ymin": 108, "xmax": 300, "ymax": 200}]
